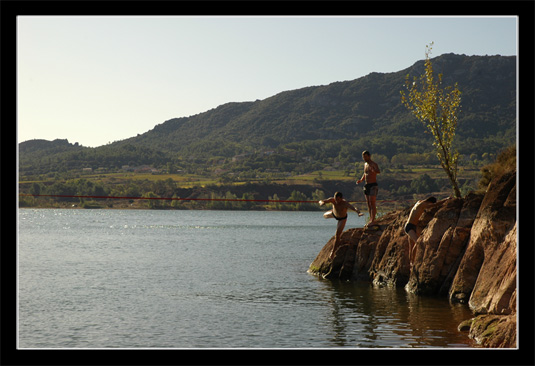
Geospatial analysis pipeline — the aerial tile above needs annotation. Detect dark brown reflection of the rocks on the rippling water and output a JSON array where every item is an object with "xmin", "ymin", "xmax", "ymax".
[{"xmin": 312, "ymin": 279, "xmax": 474, "ymax": 348}]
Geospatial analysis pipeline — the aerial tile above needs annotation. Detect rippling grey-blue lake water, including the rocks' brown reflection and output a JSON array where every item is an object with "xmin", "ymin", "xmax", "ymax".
[{"xmin": 18, "ymin": 209, "xmax": 472, "ymax": 348}]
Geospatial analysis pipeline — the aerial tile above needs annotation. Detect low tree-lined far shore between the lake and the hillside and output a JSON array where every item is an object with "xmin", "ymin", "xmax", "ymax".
[{"xmin": 19, "ymin": 170, "xmax": 474, "ymax": 210}]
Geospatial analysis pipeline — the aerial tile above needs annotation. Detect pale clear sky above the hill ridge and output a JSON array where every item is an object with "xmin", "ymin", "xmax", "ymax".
[{"xmin": 17, "ymin": 16, "xmax": 518, "ymax": 147}]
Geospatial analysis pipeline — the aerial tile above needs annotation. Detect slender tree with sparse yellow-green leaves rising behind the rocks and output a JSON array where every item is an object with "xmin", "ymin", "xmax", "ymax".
[{"xmin": 401, "ymin": 43, "xmax": 461, "ymax": 198}]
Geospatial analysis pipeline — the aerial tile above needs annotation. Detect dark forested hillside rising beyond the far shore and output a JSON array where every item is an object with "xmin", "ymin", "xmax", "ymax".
[{"xmin": 19, "ymin": 54, "xmax": 516, "ymax": 175}]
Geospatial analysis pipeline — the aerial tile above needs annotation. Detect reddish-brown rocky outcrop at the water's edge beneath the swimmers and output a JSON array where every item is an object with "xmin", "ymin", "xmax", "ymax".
[{"xmin": 309, "ymin": 171, "xmax": 517, "ymax": 347}]
